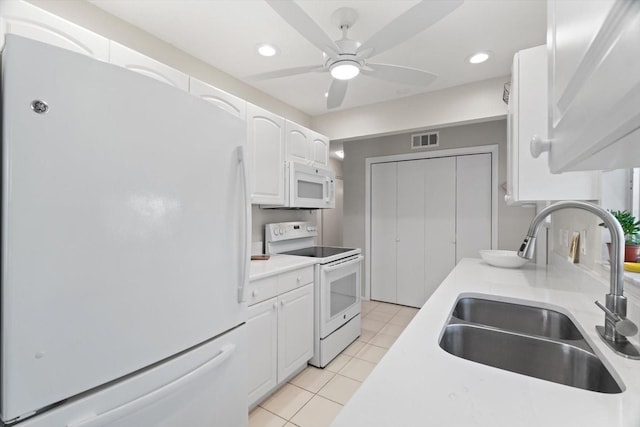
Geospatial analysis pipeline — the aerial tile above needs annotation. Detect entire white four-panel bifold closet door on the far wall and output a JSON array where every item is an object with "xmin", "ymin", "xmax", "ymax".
[{"xmin": 371, "ymin": 154, "xmax": 492, "ymax": 307}]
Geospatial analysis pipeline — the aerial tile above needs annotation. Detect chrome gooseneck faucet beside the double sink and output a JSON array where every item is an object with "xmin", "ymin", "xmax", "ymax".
[{"xmin": 518, "ymin": 201, "xmax": 640, "ymax": 359}]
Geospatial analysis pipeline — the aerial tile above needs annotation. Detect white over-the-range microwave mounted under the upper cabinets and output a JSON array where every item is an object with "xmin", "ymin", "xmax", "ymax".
[{"xmin": 262, "ymin": 161, "xmax": 336, "ymax": 209}]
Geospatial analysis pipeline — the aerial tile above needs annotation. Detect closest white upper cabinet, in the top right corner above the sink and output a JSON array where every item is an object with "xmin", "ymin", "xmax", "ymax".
[{"xmin": 547, "ymin": 0, "xmax": 640, "ymax": 173}]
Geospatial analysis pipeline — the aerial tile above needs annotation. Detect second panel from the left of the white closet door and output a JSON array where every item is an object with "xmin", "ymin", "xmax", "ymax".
[{"xmin": 396, "ymin": 160, "xmax": 429, "ymax": 307}]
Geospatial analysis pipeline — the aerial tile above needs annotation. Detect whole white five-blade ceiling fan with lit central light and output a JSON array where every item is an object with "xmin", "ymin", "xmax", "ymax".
[{"xmin": 252, "ymin": 0, "xmax": 463, "ymax": 109}]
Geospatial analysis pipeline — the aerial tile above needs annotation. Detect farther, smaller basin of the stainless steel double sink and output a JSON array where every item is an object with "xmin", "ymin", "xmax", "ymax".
[{"xmin": 452, "ymin": 298, "xmax": 582, "ymax": 340}]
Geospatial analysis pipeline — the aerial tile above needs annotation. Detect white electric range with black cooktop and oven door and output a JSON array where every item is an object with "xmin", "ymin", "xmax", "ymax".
[{"xmin": 265, "ymin": 222, "xmax": 363, "ymax": 368}]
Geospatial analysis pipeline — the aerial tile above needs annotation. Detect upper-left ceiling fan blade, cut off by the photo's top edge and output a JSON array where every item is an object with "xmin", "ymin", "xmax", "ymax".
[{"xmin": 266, "ymin": 0, "xmax": 340, "ymax": 57}]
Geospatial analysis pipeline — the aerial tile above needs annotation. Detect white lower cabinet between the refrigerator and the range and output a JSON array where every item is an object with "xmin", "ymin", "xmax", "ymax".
[{"xmin": 247, "ymin": 267, "xmax": 313, "ymax": 408}]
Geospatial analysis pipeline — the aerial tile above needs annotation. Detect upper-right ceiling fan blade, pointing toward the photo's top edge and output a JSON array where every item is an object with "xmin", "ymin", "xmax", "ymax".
[{"xmin": 358, "ymin": 0, "xmax": 463, "ymax": 56}]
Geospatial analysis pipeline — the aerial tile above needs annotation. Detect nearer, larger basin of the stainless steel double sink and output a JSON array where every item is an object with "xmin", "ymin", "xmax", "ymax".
[{"xmin": 440, "ymin": 324, "xmax": 622, "ymax": 393}]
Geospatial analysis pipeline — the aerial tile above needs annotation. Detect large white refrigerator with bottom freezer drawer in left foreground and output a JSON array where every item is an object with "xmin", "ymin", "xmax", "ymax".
[{"xmin": 0, "ymin": 35, "xmax": 250, "ymax": 427}]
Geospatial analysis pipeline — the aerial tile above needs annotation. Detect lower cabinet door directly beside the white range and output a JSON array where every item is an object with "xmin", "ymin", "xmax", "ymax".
[{"xmin": 278, "ymin": 283, "xmax": 313, "ymax": 383}]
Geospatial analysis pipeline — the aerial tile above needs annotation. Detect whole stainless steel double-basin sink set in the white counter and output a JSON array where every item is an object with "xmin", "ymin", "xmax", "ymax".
[{"xmin": 440, "ymin": 298, "xmax": 623, "ymax": 393}]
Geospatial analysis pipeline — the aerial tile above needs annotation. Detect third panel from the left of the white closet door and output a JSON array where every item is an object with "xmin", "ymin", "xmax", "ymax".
[{"xmin": 422, "ymin": 157, "xmax": 456, "ymax": 301}]
